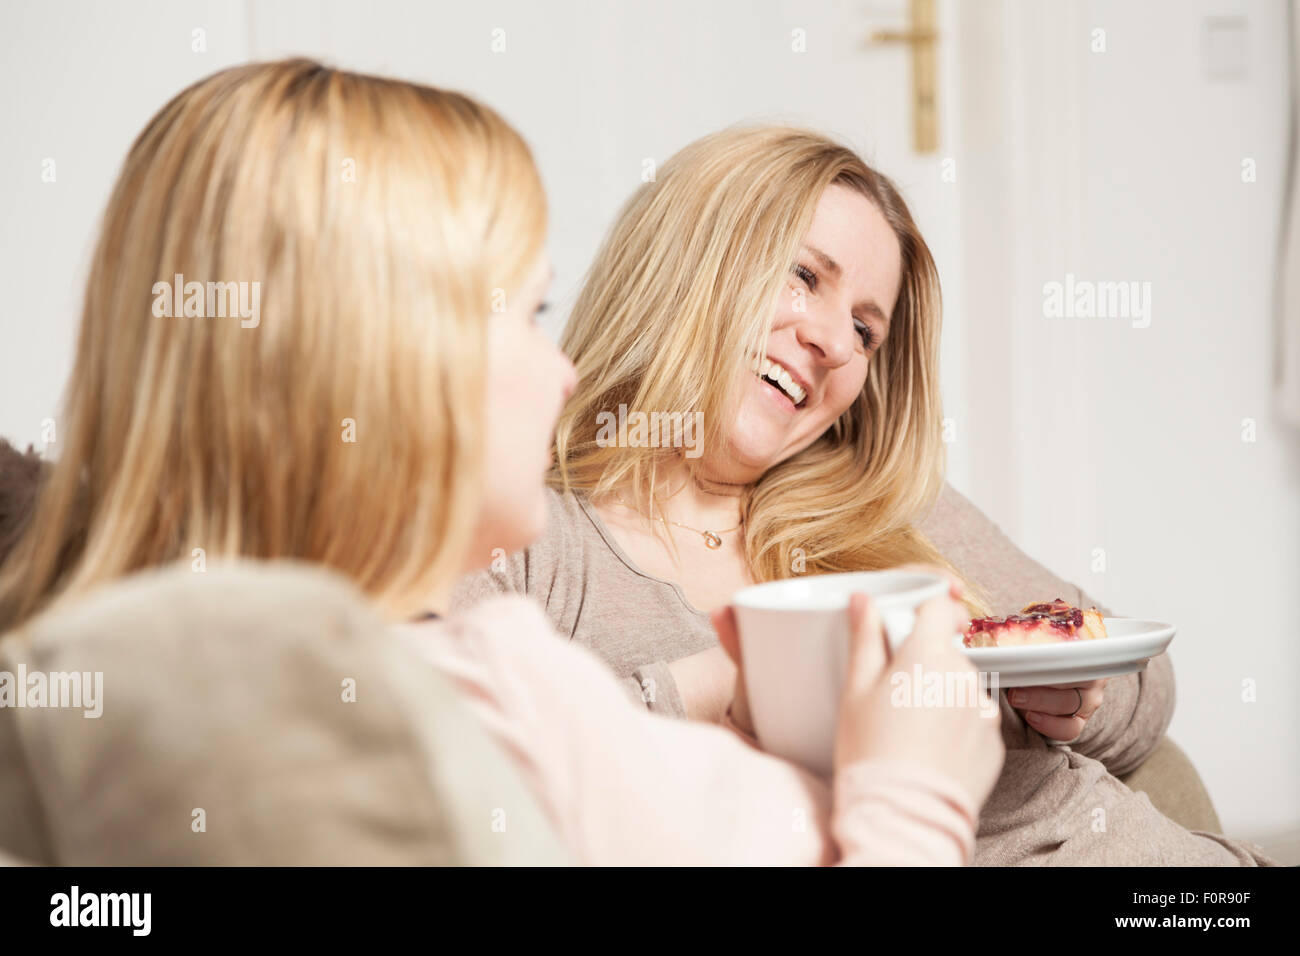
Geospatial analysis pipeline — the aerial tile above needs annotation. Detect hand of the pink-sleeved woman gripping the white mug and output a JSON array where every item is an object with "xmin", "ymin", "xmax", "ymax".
[{"xmin": 835, "ymin": 587, "xmax": 1005, "ymax": 806}]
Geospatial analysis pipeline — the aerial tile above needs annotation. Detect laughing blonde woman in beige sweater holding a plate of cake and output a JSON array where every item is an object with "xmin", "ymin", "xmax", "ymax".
[{"xmin": 456, "ymin": 126, "xmax": 1279, "ymax": 864}]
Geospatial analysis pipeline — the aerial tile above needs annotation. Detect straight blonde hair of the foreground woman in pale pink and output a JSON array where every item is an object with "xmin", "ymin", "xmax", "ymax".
[{"xmin": 0, "ymin": 60, "xmax": 546, "ymax": 630}]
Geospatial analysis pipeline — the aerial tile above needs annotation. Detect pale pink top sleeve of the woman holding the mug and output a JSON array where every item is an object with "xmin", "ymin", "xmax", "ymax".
[{"xmin": 399, "ymin": 597, "xmax": 974, "ymax": 866}]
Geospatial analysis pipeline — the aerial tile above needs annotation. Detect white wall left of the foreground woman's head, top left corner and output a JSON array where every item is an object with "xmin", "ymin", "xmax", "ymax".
[{"xmin": 0, "ymin": 0, "xmax": 247, "ymax": 453}]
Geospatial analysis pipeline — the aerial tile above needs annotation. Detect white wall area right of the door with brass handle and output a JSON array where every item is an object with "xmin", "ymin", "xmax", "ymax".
[{"xmin": 954, "ymin": 0, "xmax": 1300, "ymax": 834}]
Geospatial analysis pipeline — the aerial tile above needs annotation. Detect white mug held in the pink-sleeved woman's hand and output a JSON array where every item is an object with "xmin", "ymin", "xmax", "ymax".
[{"xmin": 731, "ymin": 571, "xmax": 948, "ymax": 777}]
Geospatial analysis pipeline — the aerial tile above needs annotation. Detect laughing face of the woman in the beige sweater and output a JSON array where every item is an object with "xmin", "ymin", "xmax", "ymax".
[{"xmin": 703, "ymin": 186, "xmax": 902, "ymax": 484}]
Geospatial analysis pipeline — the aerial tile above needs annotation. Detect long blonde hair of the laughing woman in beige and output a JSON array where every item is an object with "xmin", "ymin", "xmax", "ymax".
[{"xmin": 551, "ymin": 126, "xmax": 983, "ymax": 609}]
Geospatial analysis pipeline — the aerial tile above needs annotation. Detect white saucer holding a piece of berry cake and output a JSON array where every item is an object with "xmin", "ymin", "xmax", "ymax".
[{"xmin": 962, "ymin": 618, "xmax": 1175, "ymax": 688}]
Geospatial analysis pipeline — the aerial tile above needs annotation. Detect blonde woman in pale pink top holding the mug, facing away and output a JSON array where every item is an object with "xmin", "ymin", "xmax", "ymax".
[{"xmin": 0, "ymin": 60, "xmax": 1001, "ymax": 864}]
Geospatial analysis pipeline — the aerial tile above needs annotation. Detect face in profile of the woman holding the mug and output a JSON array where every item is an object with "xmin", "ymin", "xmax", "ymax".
[{"xmin": 469, "ymin": 255, "xmax": 576, "ymax": 567}]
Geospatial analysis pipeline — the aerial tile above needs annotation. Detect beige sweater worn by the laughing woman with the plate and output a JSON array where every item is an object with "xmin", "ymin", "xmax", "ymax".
[{"xmin": 455, "ymin": 486, "xmax": 1273, "ymax": 866}]
